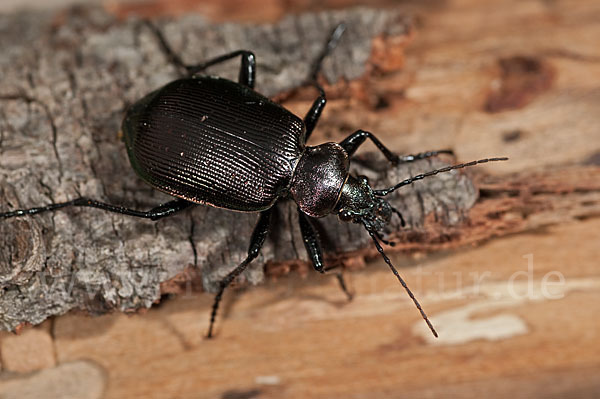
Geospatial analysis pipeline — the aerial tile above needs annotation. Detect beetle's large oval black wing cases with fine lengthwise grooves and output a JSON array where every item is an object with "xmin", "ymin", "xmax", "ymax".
[{"xmin": 123, "ymin": 77, "xmax": 304, "ymax": 212}]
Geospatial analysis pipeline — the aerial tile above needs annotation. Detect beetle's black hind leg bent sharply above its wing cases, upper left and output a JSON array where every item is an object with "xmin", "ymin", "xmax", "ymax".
[{"xmin": 144, "ymin": 21, "xmax": 256, "ymax": 88}]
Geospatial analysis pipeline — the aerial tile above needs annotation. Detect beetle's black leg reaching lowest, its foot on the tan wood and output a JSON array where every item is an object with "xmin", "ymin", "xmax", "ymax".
[{"xmin": 207, "ymin": 208, "xmax": 273, "ymax": 338}]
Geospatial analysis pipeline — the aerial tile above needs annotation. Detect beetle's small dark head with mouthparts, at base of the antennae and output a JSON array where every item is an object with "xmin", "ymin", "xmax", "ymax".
[{"xmin": 335, "ymin": 176, "xmax": 403, "ymax": 231}]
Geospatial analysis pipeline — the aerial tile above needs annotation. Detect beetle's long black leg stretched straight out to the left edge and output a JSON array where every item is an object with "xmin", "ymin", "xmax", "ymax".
[{"xmin": 0, "ymin": 197, "xmax": 196, "ymax": 220}]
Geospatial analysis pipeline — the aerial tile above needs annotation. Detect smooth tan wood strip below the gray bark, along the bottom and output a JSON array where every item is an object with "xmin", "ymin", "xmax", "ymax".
[{"xmin": 0, "ymin": 218, "xmax": 600, "ymax": 399}]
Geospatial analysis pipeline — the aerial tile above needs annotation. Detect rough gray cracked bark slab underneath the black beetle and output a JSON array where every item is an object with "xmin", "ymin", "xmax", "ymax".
[{"xmin": 0, "ymin": 8, "xmax": 477, "ymax": 330}]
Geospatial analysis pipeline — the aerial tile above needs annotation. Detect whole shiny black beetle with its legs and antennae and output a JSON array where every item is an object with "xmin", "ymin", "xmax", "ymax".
[{"xmin": 0, "ymin": 23, "xmax": 507, "ymax": 337}]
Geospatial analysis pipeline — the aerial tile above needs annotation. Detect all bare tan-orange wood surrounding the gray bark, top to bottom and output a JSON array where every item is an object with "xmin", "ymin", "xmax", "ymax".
[{"xmin": 0, "ymin": 0, "xmax": 600, "ymax": 399}]
